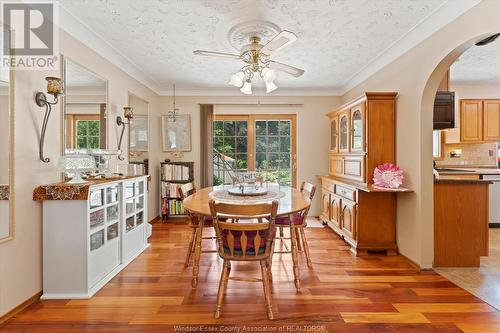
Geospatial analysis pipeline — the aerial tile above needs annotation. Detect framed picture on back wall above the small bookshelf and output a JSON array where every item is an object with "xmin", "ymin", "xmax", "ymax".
[{"xmin": 161, "ymin": 114, "xmax": 191, "ymax": 151}]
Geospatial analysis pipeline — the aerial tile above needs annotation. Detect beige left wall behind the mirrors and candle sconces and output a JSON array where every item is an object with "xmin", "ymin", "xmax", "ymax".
[{"xmin": 0, "ymin": 32, "xmax": 158, "ymax": 316}]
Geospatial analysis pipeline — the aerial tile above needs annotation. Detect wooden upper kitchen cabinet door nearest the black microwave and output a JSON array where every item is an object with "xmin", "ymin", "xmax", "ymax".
[{"xmin": 460, "ymin": 99, "xmax": 483, "ymax": 142}]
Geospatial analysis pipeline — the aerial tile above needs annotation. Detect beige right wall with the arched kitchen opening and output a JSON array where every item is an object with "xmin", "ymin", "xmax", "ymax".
[{"xmin": 342, "ymin": 0, "xmax": 500, "ymax": 268}]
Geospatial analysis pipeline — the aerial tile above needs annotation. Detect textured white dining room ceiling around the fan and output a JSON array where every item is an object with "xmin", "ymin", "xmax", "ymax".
[{"xmin": 60, "ymin": 0, "xmax": 446, "ymax": 90}]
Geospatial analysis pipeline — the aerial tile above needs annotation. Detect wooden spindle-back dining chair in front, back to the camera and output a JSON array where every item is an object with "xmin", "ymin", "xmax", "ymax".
[{"xmin": 209, "ymin": 200, "xmax": 278, "ymax": 319}]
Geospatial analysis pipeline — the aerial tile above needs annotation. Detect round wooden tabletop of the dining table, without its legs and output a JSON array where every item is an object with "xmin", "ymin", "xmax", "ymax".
[{"xmin": 182, "ymin": 185, "xmax": 311, "ymax": 216}]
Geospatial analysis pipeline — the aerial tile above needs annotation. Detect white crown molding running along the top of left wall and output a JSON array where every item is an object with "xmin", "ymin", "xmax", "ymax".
[{"xmin": 59, "ymin": 3, "xmax": 159, "ymax": 94}]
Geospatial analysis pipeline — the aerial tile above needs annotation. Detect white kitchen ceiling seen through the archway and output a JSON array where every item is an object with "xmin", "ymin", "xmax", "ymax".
[{"xmin": 450, "ymin": 38, "xmax": 500, "ymax": 85}]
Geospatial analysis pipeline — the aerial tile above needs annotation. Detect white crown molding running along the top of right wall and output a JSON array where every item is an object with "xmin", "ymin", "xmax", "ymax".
[{"xmin": 339, "ymin": 0, "xmax": 482, "ymax": 95}]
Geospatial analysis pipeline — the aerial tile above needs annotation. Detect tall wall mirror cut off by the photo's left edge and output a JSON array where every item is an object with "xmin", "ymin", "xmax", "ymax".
[{"xmin": 0, "ymin": 24, "xmax": 14, "ymax": 243}]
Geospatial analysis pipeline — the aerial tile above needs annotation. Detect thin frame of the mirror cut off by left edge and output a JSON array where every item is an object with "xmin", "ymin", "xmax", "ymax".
[{"xmin": 0, "ymin": 27, "xmax": 16, "ymax": 244}]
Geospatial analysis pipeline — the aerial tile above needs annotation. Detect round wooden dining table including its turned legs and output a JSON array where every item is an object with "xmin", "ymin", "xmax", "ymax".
[{"xmin": 182, "ymin": 185, "xmax": 311, "ymax": 289}]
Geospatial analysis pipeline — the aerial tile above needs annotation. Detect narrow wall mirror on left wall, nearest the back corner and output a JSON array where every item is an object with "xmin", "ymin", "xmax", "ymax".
[{"xmin": 128, "ymin": 93, "xmax": 149, "ymax": 174}]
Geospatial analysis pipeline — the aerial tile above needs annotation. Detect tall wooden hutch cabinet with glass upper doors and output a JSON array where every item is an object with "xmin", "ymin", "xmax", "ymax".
[{"xmin": 320, "ymin": 92, "xmax": 397, "ymax": 255}]
